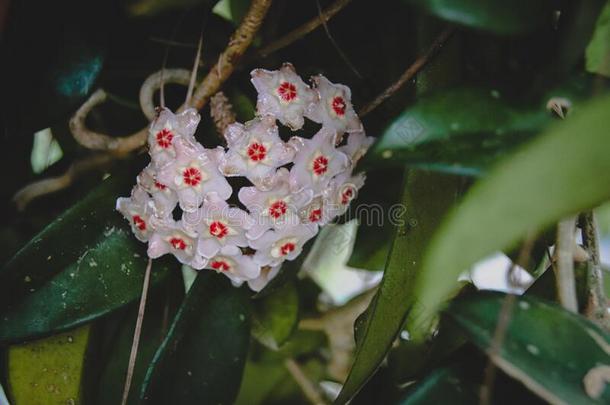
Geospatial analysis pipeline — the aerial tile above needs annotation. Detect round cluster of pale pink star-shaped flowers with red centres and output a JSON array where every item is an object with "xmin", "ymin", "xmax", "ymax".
[{"xmin": 117, "ymin": 64, "xmax": 372, "ymax": 291}]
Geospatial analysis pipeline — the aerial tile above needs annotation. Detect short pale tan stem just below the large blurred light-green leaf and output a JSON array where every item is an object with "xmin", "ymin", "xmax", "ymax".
[{"xmin": 553, "ymin": 217, "xmax": 578, "ymax": 313}]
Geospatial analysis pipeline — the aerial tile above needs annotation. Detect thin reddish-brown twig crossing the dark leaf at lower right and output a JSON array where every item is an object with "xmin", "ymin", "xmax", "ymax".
[{"xmin": 479, "ymin": 234, "xmax": 536, "ymax": 405}]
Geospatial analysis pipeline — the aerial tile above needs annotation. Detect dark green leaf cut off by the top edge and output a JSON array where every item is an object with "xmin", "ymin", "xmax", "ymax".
[{"xmin": 407, "ymin": 0, "xmax": 555, "ymax": 35}]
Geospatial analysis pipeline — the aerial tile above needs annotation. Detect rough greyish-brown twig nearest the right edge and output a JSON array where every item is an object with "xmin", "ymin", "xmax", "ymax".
[{"xmin": 580, "ymin": 211, "xmax": 610, "ymax": 328}]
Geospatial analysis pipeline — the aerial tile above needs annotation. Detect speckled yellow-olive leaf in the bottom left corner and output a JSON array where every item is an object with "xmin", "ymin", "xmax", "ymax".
[{"xmin": 8, "ymin": 326, "xmax": 90, "ymax": 405}]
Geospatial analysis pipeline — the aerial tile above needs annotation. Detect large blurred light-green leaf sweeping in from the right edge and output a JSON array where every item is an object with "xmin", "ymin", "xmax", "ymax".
[{"xmin": 415, "ymin": 93, "xmax": 610, "ymax": 324}]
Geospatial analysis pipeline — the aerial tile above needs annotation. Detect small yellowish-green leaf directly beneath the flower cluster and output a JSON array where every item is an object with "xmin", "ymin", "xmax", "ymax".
[{"xmin": 252, "ymin": 282, "xmax": 299, "ymax": 350}]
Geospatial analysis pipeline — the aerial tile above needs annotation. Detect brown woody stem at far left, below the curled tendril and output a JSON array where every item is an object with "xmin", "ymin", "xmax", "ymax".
[{"xmin": 13, "ymin": 153, "xmax": 115, "ymax": 211}]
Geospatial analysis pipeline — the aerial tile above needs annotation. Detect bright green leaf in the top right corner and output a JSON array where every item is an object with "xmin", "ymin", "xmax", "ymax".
[{"xmin": 585, "ymin": 2, "xmax": 610, "ymax": 77}]
